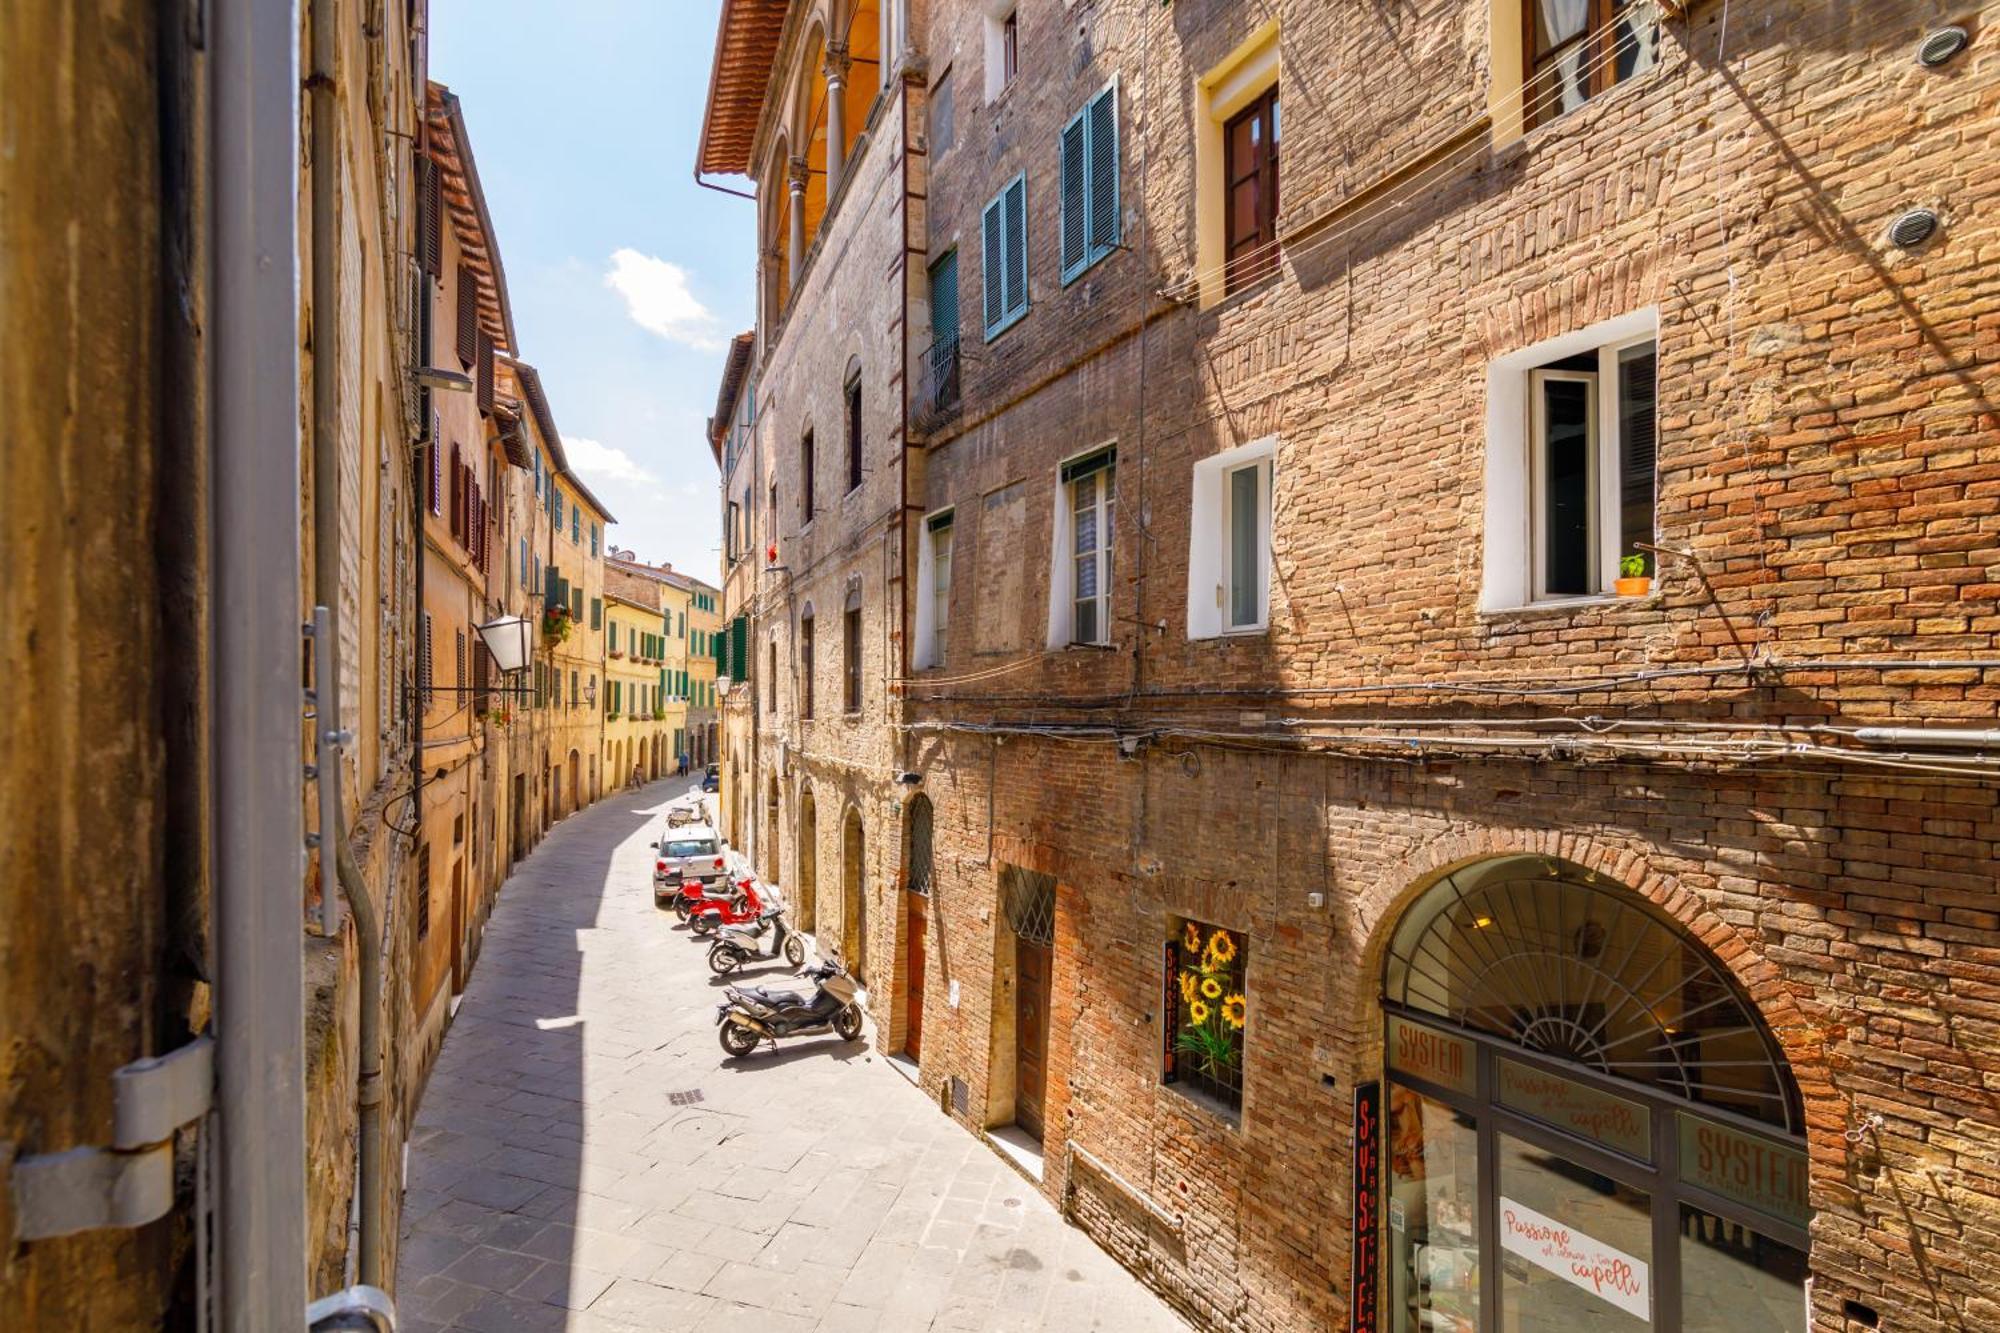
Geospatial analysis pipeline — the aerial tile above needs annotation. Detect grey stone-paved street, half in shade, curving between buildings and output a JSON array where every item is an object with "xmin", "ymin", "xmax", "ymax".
[{"xmin": 398, "ymin": 781, "xmax": 1184, "ymax": 1333}]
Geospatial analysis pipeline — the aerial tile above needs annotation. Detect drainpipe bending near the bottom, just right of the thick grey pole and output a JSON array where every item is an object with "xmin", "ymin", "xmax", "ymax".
[{"xmin": 306, "ymin": 0, "xmax": 382, "ymax": 1287}]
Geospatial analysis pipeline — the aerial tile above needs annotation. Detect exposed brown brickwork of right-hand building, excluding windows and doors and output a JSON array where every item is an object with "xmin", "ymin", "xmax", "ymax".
[{"xmin": 716, "ymin": 0, "xmax": 2000, "ymax": 1329}]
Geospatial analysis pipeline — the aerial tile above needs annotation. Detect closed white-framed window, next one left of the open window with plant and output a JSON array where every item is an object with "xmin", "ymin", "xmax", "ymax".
[{"xmin": 1188, "ymin": 436, "xmax": 1278, "ymax": 638}]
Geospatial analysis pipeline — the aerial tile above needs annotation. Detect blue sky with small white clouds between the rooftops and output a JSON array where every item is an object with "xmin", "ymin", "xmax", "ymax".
[{"xmin": 430, "ymin": 0, "xmax": 756, "ymax": 582}]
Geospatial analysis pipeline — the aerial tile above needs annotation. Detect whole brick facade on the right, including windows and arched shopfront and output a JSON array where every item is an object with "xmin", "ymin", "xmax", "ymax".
[{"xmin": 700, "ymin": 0, "xmax": 2000, "ymax": 1329}]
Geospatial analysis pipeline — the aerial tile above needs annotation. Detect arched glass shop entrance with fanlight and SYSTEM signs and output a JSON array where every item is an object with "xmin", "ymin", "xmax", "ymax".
[{"xmin": 1376, "ymin": 857, "xmax": 1812, "ymax": 1333}]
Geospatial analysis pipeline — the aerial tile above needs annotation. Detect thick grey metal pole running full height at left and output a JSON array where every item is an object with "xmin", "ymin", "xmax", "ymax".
[{"xmin": 208, "ymin": 0, "xmax": 306, "ymax": 1333}]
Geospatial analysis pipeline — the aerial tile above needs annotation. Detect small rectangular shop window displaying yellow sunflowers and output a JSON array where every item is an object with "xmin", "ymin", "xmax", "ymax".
[{"xmin": 1164, "ymin": 921, "xmax": 1248, "ymax": 1113}]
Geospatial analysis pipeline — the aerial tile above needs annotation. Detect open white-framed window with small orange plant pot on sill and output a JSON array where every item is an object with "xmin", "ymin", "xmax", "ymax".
[{"xmin": 1480, "ymin": 308, "xmax": 1658, "ymax": 610}]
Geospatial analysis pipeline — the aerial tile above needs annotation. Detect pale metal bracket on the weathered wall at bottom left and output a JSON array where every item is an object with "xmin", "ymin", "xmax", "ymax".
[{"xmin": 0, "ymin": 1037, "xmax": 216, "ymax": 1243}]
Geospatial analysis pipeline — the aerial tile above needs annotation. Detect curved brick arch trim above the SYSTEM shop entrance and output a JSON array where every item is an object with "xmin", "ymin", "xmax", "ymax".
[{"xmin": 1352, "ymin": 829, "xmax": 1848, "ymax": 1112}]
